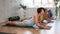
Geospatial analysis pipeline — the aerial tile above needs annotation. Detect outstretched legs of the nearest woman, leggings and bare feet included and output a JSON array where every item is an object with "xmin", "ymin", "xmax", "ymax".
[{"xmin": 7, "ymin": 18, "xmax": 34, "ymax": 26}]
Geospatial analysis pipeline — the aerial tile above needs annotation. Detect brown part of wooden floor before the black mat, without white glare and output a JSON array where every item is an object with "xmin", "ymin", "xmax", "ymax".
[{"xmin": 0, "ymin": 26, "xmax": 40, "ymax": 34}]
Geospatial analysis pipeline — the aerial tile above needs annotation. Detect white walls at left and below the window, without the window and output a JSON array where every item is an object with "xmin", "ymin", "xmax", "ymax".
[{"xmin": 0, "ymin": 0, "xmax": 54, "ymax": 22}]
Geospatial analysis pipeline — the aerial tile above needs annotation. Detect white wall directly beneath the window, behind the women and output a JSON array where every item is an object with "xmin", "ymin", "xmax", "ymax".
[{"xmin": 19, "ymin": 8, "xmax": 55, "ymax": 19}]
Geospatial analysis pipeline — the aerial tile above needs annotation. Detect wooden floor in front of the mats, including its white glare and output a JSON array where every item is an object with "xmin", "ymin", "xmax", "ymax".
[{"xmin": 0, "ymin": 21, "xmax": 57, "ymax": 34}]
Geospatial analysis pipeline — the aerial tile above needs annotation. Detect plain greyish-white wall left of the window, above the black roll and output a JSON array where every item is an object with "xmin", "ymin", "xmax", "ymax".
[{"xmin": 0, "ymin": 0, "xmax": 20, "ymax": 22}]
